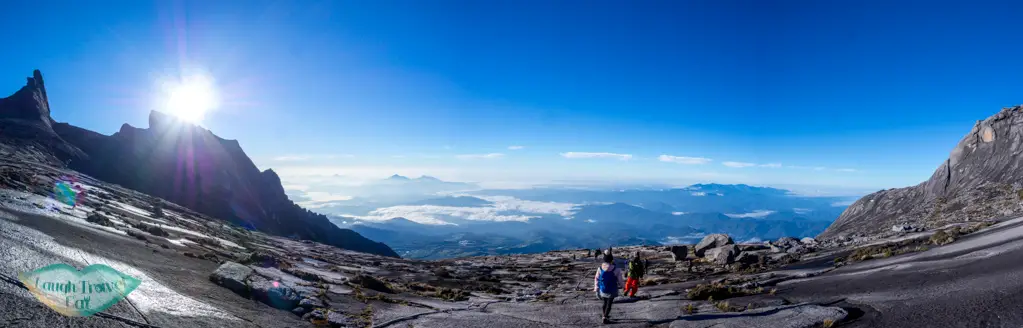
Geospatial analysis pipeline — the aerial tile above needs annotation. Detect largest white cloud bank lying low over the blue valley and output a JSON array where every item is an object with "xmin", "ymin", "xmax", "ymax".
[{"xmin": 355, "ymin": 196, "xmax": 577, "ymax": 225}]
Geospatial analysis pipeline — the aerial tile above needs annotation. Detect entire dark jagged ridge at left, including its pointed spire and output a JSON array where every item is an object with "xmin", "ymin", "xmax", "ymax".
[{"xmin": 0, "ymin": 71, "xmax": 398, "ymax": 256}]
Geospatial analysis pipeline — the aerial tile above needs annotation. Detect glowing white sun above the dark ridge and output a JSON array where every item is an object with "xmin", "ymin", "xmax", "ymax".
[{"xmin": 163, "ymin": 76, "xmax": 218, "ymax": 123}]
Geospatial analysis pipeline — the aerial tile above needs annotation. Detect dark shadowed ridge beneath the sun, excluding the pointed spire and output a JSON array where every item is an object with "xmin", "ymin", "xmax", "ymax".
[{"xmin": 58, "ymin": 111, "xmax": 398, "ymax": 256}]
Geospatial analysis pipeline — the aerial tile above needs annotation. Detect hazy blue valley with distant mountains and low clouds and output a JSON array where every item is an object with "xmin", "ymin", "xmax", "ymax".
[{"xmin": 288, "ymin": 175, "xmax": 855, "ymax": 260}]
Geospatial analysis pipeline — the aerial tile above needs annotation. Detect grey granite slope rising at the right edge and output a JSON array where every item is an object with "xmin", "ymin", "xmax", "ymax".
[{"xmin": 818, "ymin": 106, "xmax": 1023, "ymax": 239}]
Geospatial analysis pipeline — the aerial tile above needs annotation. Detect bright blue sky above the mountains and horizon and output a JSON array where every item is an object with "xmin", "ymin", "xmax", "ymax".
[{"xmin": 0, "ymin": 0, "xmax": 1023, "ymax": 188}]
